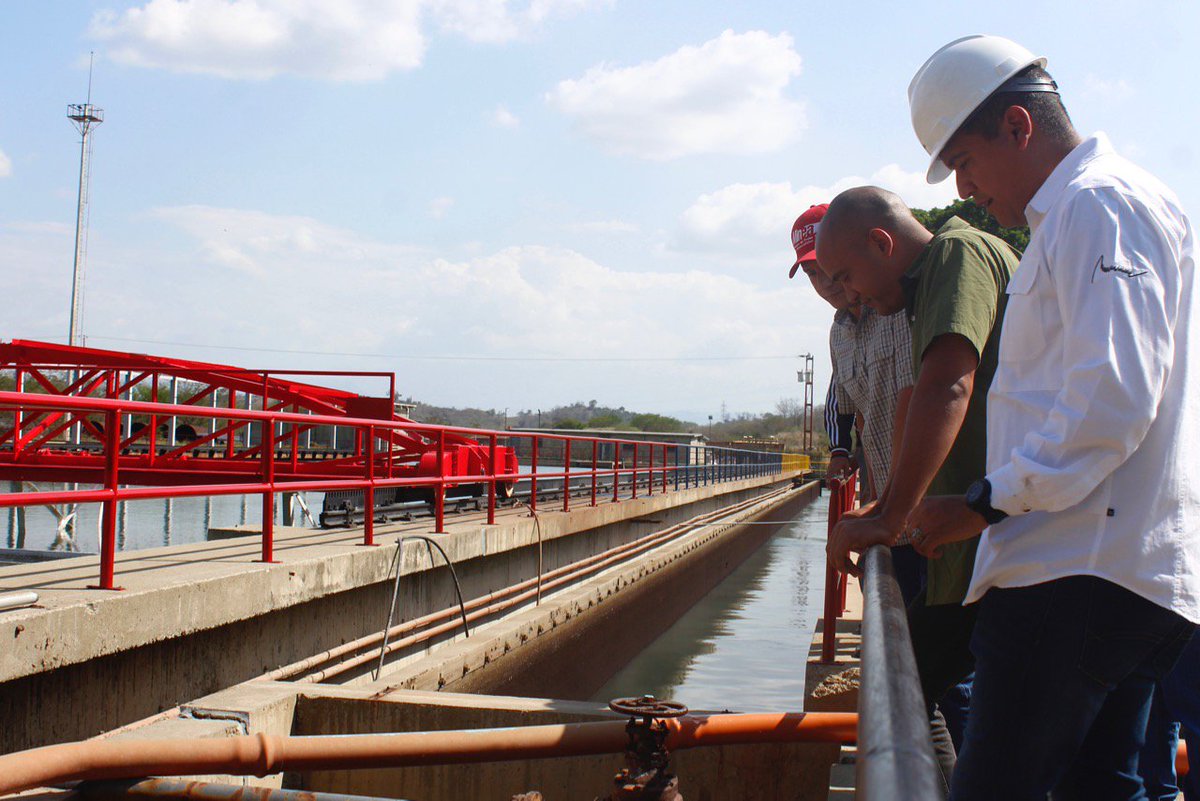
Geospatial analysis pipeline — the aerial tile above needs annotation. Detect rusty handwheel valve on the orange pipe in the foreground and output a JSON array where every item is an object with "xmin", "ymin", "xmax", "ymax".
[{"xmin": 608, "ymin": 695, "xmax": 688, "ymax": 801}]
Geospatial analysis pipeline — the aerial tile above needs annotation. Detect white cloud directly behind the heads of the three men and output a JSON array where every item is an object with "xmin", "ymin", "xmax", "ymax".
[{"xmin": 672, "ymin": 164, "xmax": 954, "ymax": 260}]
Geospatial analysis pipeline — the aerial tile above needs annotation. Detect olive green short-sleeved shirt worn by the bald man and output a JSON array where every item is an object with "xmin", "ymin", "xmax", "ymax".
[{"xmin": 901, "ymin": 217, "xmax": 1021, "ymax": 606}]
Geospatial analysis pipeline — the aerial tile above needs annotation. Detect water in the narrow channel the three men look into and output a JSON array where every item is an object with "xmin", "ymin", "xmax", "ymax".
[{"xmin": 594, "ymin": 500, "xmax": 827, "ymax": 712}]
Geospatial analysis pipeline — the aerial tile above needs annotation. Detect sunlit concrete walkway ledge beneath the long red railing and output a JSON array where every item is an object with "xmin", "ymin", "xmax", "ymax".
[{"xmin": 0, "ymin": 475, "xmax": 806, "ymax": 682}]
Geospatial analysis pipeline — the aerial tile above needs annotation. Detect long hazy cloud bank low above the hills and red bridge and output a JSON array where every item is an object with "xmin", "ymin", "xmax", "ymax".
[{"xmin": 0, "ymin": 206, "xmax": 829, "ymax": 414}]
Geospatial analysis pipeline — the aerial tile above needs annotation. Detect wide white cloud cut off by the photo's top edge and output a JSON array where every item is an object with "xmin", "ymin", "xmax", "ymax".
[{"xmin": 90, "ymin": 0, "xmax": 604, "ymax": 80}]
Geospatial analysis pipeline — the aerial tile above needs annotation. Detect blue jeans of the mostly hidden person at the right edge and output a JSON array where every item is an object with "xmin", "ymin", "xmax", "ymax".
[{"xmin": 1138, "ymin": 636, "xmax": 1200, "ymax": 801}]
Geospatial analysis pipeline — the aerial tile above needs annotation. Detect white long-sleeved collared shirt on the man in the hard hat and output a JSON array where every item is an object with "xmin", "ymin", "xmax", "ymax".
[{"xmin": 966, "ymin": 134, "xmax": 1200, "ymax": 622}]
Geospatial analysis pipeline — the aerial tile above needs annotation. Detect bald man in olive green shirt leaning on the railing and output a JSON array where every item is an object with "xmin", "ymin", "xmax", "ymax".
[{"xmin": 817, "ymin": 187, "xmax": 1020, "ymax": 778}]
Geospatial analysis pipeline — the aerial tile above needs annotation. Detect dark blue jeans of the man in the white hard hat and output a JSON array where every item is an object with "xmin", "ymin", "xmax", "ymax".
[{"xmin": 950, "ymin": 576, "xmax": 1194, "ymax": 801}]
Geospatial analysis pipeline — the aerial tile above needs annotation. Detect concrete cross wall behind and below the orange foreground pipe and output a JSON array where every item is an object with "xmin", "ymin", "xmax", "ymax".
[{"xmin": 96, "ymin": 682, "xmax": 839, "ymax": 801}]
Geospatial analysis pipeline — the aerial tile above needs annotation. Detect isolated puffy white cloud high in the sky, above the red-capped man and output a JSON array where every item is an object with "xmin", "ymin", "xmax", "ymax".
[{"xmin": 546, "ymin": 30, "xmax": 805, "ymax": 159}]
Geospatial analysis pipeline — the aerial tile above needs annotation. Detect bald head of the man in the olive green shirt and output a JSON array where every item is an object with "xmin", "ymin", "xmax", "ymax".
[{"xmin": 817, "ymin": 186, "xmax": 932, "ymax": 314}]
